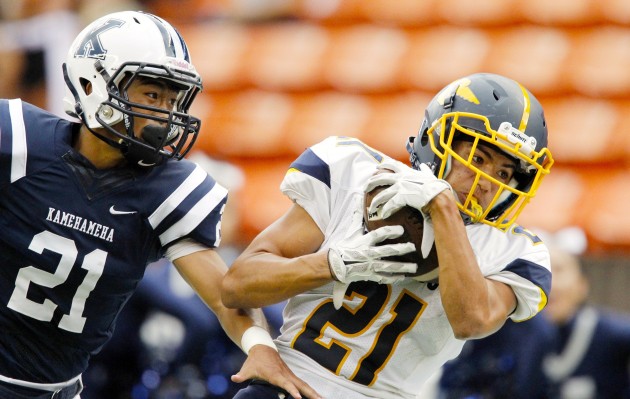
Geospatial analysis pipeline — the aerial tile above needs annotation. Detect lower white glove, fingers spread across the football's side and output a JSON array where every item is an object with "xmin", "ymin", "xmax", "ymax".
[{"xmin": 328, "ymin": 200, "xmax": 418, "ymax": 309}]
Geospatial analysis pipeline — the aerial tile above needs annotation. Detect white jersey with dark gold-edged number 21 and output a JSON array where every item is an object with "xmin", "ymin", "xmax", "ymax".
[{"xmin": 276, "ymin": 137, "xmax": 551, "ymax": 399}]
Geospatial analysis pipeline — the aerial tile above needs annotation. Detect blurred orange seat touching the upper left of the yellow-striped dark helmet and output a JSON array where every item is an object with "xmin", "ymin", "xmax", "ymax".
[{"xmin": 398, "ymin": 26, "xmax": 490, "ymax": 92}]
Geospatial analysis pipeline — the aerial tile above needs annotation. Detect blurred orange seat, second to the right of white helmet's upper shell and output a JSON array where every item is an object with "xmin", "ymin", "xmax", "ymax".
[{"xmin": 244, "ymin": 22, "xmax": 329, "ymax": 91}]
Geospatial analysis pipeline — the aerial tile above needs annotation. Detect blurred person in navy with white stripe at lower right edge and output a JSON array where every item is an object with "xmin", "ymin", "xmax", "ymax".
[{"xmin": 542, "ymin": 245, "xmax": 630, "ymax": 399}]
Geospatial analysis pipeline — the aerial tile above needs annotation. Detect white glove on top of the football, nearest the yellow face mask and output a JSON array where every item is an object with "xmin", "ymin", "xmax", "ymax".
[{"xmin": 365, "ymin": 162, "xmax": 455, "ymax": 258}]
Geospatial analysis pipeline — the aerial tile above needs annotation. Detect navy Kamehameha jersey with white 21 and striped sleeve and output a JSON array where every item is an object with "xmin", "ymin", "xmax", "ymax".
[{"xmin": 0, "ymin": 100, "xmax": 227, "ymax": 383}]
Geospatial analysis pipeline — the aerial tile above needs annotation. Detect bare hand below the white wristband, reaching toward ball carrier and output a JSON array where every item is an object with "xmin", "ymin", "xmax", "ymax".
[{"xmin": 232, "ymin": 345, "xmax": 322, "ymax": 399}]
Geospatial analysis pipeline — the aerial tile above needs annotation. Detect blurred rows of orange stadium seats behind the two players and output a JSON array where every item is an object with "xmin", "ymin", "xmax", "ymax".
[{"xmin": 0, "ymin": 0, "xmax": 630, "ymax": 399}]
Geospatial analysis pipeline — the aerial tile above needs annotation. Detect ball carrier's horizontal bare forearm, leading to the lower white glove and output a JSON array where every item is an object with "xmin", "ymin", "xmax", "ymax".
[{"xmin": 221, "ymin": 251, "xmax": 332, "ymax": 308}]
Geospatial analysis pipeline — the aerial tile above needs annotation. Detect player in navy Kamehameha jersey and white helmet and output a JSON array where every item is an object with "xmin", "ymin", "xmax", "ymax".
[{"xmin": 0, "ymin": 11, "xmax": 318, "ymax": 398}]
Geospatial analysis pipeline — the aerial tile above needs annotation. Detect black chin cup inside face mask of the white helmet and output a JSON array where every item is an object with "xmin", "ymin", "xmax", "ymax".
[{"xmin": 122, "ymin": 125, "xmax": 170, "ymax": 168}]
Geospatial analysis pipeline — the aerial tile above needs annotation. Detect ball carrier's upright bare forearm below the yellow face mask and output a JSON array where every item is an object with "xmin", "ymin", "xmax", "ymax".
[{"xmin": 431, "ymin": 196, "xmax": 489, "ymax": 339}]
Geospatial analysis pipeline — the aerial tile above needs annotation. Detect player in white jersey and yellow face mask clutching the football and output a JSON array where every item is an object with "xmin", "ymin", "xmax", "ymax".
[{"xmin": 222, "ymin": 74, "xmax": 553, "ymax": 399}]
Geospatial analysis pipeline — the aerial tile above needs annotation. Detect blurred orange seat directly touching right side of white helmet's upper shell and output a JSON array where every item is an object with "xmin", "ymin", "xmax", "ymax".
[{"xmin": 179, "ymin": 23, "xmax": 251, "ymax": 91}]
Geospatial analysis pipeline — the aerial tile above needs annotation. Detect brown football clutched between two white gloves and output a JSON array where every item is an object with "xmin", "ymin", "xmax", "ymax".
[{"xmin": 363, "ymin": 177, "xmax": 438, "ymax": 282}]
